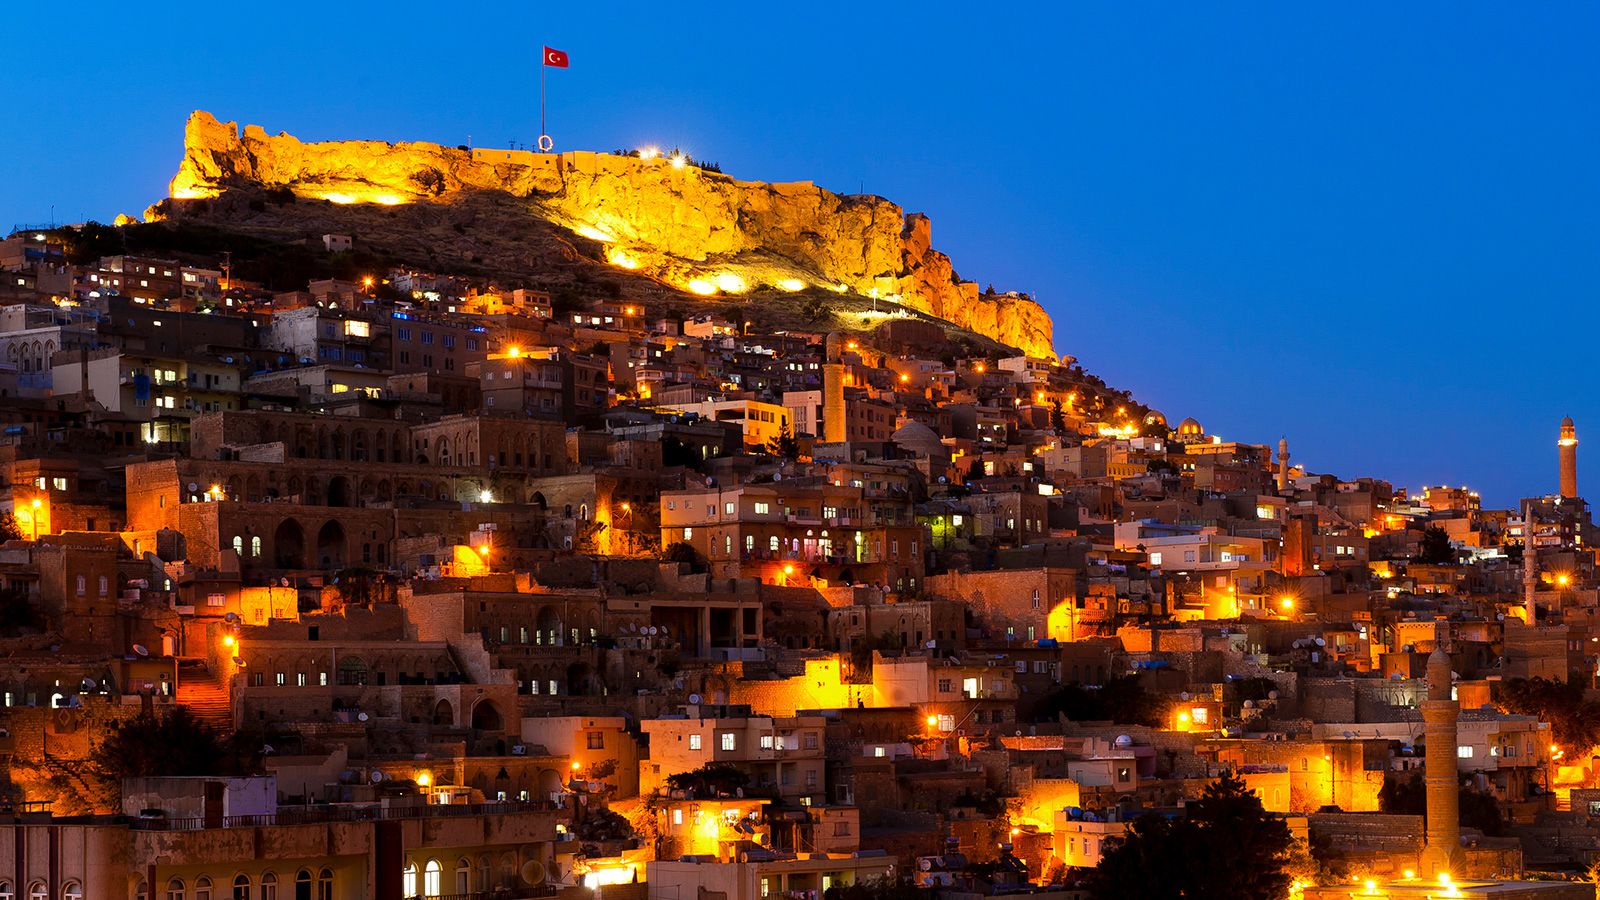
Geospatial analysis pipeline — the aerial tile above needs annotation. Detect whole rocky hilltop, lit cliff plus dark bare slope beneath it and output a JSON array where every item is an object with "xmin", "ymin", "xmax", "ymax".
[{"xmin": 147, "ymin": 112, "xmax": 1054, "ymax": 357}]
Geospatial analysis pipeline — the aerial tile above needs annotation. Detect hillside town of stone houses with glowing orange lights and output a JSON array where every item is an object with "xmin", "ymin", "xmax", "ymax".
[{"xmin": 0, "ymin": 219, "xmax": 1600, "ymax": 900}]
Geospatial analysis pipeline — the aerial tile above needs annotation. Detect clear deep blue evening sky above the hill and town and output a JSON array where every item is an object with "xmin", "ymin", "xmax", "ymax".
[{"xmin": 0, "ymin": 2, "xmax": 1600, "ymax": 504}]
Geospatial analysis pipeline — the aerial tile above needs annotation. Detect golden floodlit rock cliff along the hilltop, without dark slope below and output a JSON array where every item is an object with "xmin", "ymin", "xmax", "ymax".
[{"xmin": 170, "ymin": 112, "xmax": 1053, "ymax": 357}]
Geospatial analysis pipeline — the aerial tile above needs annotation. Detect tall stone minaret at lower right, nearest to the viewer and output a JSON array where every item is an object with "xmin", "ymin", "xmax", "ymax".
[{"xmin": 1422, "ymin": 643, "xmax": 1462, "ymax": 881}]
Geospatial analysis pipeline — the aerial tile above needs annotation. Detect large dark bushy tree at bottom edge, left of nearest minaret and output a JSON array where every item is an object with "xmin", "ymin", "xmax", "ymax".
[{"xmin": 1088, "ymin": 772, "xmax": 1294, "ymax": 900}]
